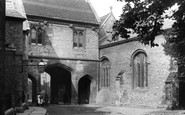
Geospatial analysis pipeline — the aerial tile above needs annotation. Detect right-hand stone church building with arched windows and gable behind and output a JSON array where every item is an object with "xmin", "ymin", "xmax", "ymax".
[{"xmin": 97, "ymin": 12, "xmax": 170, "ymax": 108}]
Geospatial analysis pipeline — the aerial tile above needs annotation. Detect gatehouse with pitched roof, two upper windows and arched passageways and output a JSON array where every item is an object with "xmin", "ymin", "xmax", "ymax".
[{"xmin": 23, "ymin": 0, "xmax": 99, "ymax": 104}]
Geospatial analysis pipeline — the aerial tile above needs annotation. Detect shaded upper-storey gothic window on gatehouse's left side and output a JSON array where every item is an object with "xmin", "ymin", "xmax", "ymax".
[{"xmin": 30, "ymin": 25, "xmax": 43, "ymax": 44}]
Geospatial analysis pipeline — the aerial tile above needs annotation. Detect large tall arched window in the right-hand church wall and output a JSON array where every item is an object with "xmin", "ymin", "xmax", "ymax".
[{"xmin": 132, "ymin": 50, "xmax": 148, "ymax": 88}]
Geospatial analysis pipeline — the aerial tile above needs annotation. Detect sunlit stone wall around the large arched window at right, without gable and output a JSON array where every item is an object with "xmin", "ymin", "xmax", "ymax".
[{"xmin": 97, "ymin": 35, "xmax": 170, "ymax": 107}]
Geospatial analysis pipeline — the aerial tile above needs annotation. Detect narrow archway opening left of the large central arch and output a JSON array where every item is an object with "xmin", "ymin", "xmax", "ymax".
[{"xmin": 27, "ymin": 74, "xmax": 37, "ymax": 105}]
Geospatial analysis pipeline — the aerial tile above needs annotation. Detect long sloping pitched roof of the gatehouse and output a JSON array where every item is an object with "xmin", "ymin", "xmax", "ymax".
[{"xmin": 23, "ymin": 0, "xmax": 99, "ymax": 24}]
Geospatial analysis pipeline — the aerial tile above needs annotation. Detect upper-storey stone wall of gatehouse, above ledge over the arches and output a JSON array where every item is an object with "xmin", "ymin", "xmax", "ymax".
[{"xmin": 29, "ymin": 22, "xmax": 98, "ymax": 60}]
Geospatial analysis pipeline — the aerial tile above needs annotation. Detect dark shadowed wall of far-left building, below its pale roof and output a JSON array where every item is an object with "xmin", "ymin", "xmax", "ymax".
[{"xmin": 6, "ymin": 18, "xmax": 27, "ymax": 107}]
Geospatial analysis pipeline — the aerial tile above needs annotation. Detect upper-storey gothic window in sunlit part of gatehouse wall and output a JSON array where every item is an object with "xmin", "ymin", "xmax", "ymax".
[{"xmin": 73, "ymin": 29, "xmax": 85, "ymax": 49}]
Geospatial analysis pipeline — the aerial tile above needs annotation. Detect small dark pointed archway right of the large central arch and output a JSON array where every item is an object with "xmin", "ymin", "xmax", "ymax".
[{"xmin": 78, "ymin": 75, "xmax": 91, "ymax": 104}]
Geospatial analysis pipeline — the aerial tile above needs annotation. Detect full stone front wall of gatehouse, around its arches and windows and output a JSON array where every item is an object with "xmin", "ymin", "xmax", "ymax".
[{"xmin": 28, "ymin": 21, "xmax": 99, "ymax": 103}]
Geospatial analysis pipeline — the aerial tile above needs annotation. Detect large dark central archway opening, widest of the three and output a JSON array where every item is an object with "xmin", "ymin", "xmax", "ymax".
[{"xmin": 45, "ymin": 66, "xmax": 71, "ymax": 104}]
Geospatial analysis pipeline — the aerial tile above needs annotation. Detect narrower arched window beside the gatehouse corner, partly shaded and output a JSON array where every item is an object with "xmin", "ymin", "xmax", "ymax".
[{"xmin": 101, "ymin": 58, "xmax": 110, "ymax": 87}]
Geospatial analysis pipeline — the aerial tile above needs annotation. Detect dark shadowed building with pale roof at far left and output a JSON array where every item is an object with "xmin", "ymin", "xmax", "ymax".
[{"xmin": 0, "ymin": 0, "xmax": 27, "ymax": 110}]
